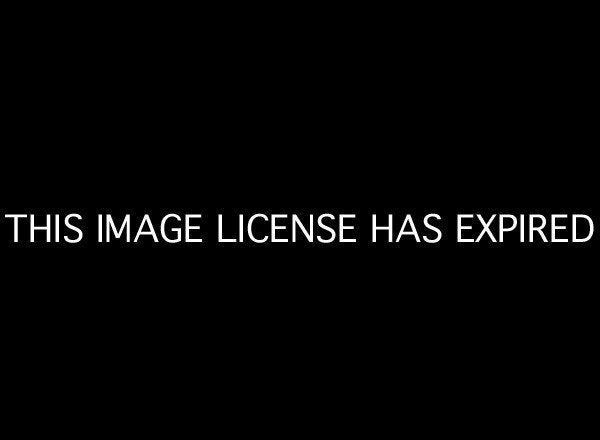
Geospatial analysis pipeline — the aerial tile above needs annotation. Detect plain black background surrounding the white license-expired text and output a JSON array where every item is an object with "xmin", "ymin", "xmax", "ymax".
[{"xmin": 1, "ymin": 5, "xmax": 598, "ymax": 433}]
